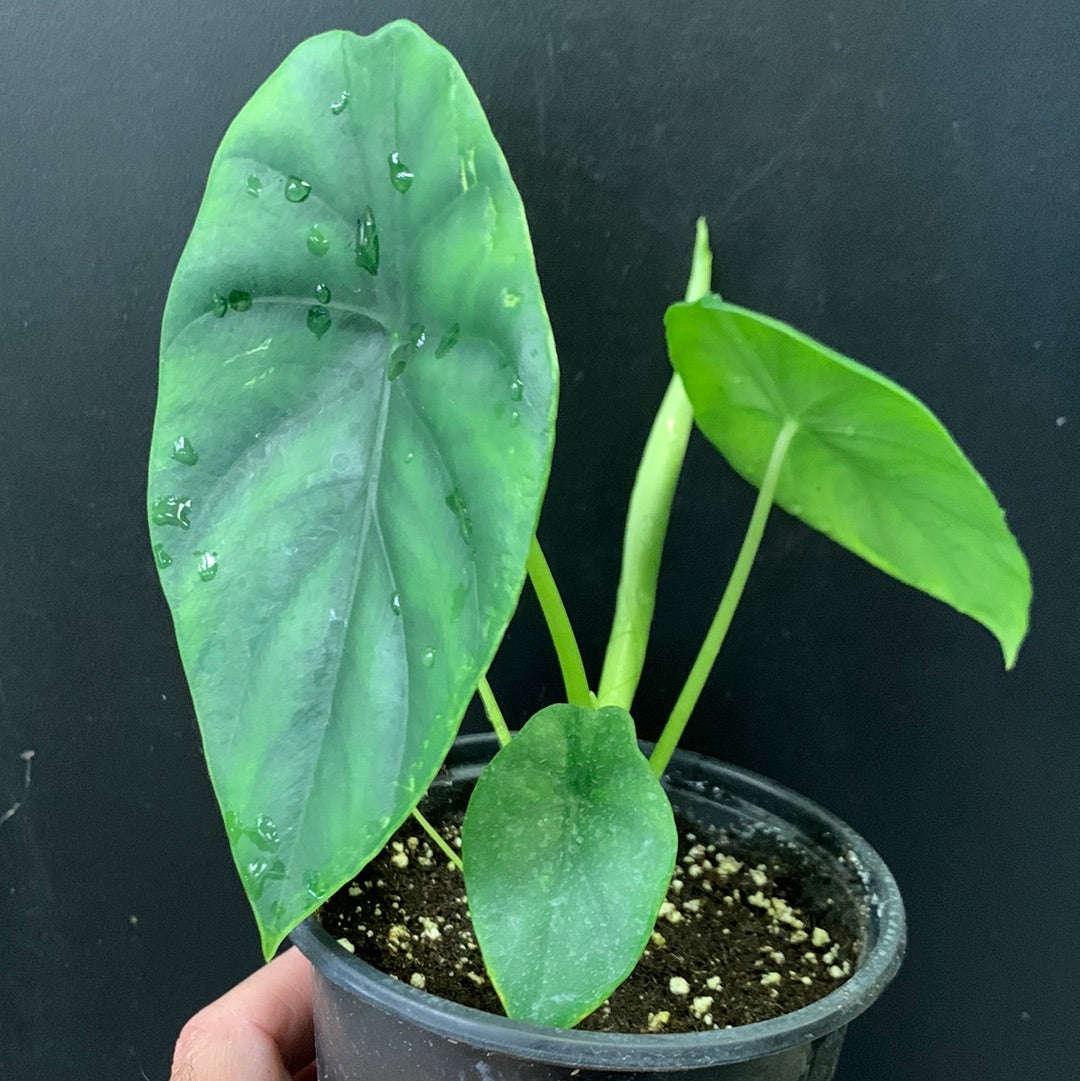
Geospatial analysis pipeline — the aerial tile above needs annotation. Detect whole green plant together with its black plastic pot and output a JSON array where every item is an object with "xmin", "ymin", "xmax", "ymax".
[{"xmin": 149, "ymin": 16, "xmax": 1030, "ymax": 1081}]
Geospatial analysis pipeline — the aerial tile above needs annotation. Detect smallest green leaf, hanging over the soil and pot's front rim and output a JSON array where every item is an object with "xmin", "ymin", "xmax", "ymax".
[{"xmin": 462, "ymin": 705, "xmax": 677, "ymax": 1027}]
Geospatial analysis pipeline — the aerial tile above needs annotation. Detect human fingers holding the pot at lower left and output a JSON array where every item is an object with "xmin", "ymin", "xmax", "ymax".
[{"xmin": 170, "ymin": 947, "xmax": 316, "ymax": 1081}]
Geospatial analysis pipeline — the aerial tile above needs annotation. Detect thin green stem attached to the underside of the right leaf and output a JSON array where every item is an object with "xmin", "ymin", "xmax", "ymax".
[{"xmin": 649, "ymin": 419, "xmax": 799, "ymax": 777}]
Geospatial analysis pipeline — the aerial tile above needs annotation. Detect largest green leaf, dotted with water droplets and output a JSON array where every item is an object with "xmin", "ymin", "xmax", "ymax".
[{"xmin": 149, "ymin": 23, "xmax": 557, "ymax": 952}]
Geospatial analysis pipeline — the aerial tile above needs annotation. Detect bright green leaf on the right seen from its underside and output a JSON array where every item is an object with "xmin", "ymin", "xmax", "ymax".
[{"xmin": 665, "ymin": 296, "xmax": 1031, "ymax": 667}]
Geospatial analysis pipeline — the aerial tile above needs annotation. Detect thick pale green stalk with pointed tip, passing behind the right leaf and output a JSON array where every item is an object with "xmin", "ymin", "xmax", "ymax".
[{"xmin": 598, "ymin": 218, "xmax": 712, "ymax": 710}]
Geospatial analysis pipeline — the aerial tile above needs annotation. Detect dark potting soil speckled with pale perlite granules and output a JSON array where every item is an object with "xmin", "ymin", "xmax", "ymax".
[{"xmin": 319, "ymin": 814, "xmax": 857, "ymax": 1032}]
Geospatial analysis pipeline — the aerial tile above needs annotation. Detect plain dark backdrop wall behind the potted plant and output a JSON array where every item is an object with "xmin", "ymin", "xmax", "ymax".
[{"xmin": 0, "ymin": 0, "xmax": 1080, "ymax": 1081}]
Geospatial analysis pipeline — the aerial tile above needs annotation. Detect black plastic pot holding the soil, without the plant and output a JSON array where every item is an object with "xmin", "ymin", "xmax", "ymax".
[{"xmin": 293, "ymin": 736, "xmax": 905, "ymax": 1081}]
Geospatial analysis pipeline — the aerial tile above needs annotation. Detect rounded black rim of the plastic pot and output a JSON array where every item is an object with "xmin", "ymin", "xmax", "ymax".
[{"xmin": 291, "ymin": 733, "xmax": 906, "ymax": 1070}]
